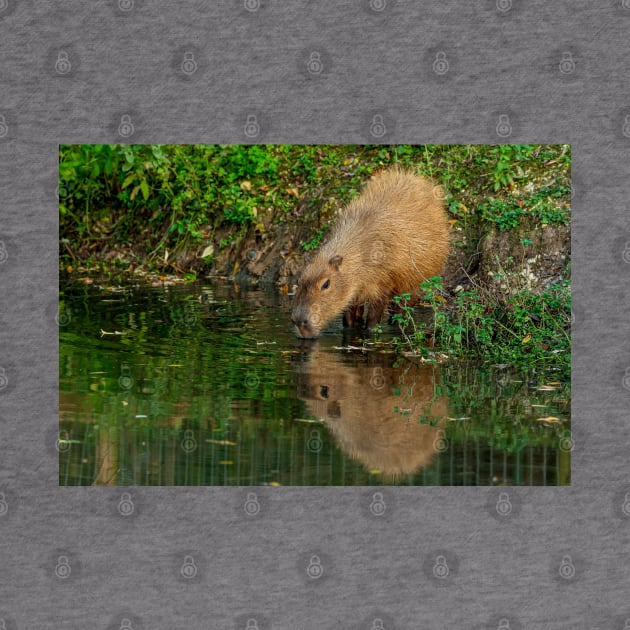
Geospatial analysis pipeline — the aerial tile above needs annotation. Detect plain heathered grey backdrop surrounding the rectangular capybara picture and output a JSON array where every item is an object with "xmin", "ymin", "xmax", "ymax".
[{"xmin": 0, "ymin": 0, "xmax": 630, "ymax": 630}]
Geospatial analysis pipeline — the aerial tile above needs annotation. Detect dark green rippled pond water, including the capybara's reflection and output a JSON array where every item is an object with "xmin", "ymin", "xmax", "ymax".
[{"xmin": 59, "ymin": 282, "xmax": 571, "ymax": 486}]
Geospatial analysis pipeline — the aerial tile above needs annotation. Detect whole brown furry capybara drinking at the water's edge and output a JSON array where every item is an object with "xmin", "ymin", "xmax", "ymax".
[{"xmin": 291, "ymin": 167, "xmax": 448, "ymax": 339}]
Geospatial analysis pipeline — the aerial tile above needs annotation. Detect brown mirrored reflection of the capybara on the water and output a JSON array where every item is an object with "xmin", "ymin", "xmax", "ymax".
[{"xmin": 297, "ymin": 350, "xmax": 447, "ymax": 478}]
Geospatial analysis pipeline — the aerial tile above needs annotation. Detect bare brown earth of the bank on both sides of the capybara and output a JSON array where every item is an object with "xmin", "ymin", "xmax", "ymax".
[{"xmin": 71, "ymin": 189, "xmax": 571, "ymax": 300}]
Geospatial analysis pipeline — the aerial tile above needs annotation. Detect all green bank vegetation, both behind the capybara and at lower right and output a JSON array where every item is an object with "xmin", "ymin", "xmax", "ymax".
[{"xmin": 59, "ymin": 145, "xmax": 571, "ymax": 377}]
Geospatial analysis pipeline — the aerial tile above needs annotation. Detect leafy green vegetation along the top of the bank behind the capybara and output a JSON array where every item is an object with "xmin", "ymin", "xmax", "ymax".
[{"xmin": 59, "ymin": 145, "xmax": 571, "ymax": 272}]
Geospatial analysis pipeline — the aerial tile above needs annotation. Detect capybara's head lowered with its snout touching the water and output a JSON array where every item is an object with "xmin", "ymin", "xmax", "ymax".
[{"xmin": 291, "ymin": 255, "xmax": 353, "ymax": 339}]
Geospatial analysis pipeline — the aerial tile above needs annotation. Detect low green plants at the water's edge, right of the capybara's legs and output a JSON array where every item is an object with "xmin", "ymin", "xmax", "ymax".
[{"xmin": 392, "ymin": 278, "xmax": 571, "ymax": 380}]
